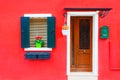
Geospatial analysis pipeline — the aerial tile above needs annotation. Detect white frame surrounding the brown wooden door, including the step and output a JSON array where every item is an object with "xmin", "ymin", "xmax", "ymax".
[{"xmin": 67, "ymin": 11, "xmax": 99, "ymax": 80}]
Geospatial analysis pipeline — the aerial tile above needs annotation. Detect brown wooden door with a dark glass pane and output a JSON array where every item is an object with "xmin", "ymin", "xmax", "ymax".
[{"xmin": 70, "ymin": 16, "xmax": 92, "ymax": 72}]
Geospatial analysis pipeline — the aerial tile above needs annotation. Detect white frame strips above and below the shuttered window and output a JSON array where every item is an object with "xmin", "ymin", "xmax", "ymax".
[{"xmin": 24, "ymin": 13, "xmax": 52, "ymax": 51}]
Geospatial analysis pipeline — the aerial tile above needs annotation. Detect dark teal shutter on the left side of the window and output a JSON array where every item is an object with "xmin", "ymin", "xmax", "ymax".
[{"xmin": 21, "ymin": 17, "xmax": 30, "ymax": 48}]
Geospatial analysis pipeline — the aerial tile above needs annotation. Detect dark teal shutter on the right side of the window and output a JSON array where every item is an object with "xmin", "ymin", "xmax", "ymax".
[{"xmin": 47, "ymin": 17, "xmax": 56, "ymax": 48}]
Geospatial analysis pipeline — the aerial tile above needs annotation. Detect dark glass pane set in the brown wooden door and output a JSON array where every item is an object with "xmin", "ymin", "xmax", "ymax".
[{"xmin": 79, "ymin": 19, "xmax": 90, "ymax": 49}]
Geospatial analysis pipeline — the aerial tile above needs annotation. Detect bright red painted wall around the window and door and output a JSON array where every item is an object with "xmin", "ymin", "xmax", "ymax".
[{"xmin": 0, "ymin": 0, "xmax": 120, "ymax": 80}]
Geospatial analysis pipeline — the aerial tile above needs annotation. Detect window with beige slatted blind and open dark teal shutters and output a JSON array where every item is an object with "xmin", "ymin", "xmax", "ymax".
[{"xmin": 21, "ymin": 16, "xmax": 55, "ymax": 49}]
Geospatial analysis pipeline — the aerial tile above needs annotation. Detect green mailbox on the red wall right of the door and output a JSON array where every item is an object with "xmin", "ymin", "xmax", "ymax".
[{"xmin": 100, "ymin": 26, "xmax": 109, "ymax": 38}]
